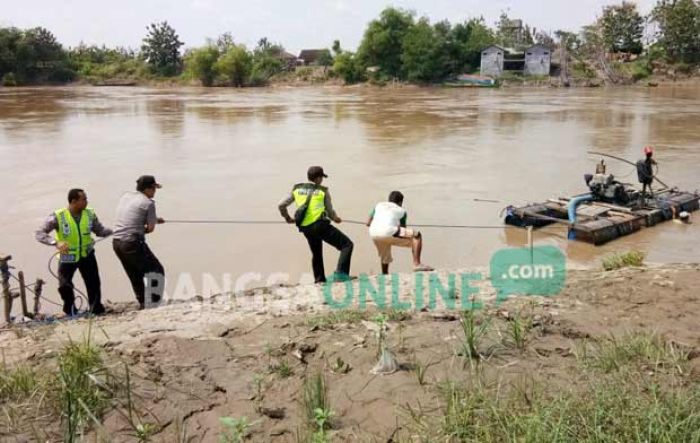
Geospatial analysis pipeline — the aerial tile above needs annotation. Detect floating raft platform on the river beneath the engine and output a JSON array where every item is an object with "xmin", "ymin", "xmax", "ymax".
[{"xmin": 505, "ymin": 189, "xmax": 700, "ymax": 246}]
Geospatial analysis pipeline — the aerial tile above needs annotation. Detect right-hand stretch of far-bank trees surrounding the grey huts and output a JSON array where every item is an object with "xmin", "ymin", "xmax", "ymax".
[{"xmin": 333, "ymin": 0, "xmax": 700, "ymax": 83}]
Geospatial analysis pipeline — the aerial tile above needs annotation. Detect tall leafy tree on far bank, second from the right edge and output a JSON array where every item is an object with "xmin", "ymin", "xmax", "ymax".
[{"xmin": 600, "ymin": 1, "xmax": 644, "ymax": 54}]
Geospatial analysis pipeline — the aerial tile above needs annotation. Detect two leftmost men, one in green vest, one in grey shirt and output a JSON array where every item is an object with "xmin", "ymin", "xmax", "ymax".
[{"xmin": 35, "ymin": 175, "xmax": 165, "ymax": 316}]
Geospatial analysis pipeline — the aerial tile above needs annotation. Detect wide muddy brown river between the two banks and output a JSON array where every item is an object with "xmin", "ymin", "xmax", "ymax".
[{"xmin": 0, "ymin": 87, "xmax": 700, "ymax": 309}]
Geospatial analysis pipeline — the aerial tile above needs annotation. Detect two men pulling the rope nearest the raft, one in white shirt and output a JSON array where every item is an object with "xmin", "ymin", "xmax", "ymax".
[{"xmin": 278, "ymin": 166, "xmax": 433, "ymax": 283}]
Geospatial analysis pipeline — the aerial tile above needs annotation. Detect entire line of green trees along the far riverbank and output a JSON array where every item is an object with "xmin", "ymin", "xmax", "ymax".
[{"xmin": 0, "ymin": 0, "xmax": 700, "ymax": 86}]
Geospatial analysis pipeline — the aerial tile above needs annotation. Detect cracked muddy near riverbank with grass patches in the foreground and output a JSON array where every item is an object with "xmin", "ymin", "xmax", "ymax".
[{"xmin": 0, "ymin": 265, "xmax": 700, "ymax": 442}]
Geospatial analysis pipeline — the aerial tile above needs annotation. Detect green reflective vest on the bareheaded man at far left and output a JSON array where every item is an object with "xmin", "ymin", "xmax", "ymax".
[{"xmin": 54, "ymin": 208, "xmax": 95, "ymax": 263}]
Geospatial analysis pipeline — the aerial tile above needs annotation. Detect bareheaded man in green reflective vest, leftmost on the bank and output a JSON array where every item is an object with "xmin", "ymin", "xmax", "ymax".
[{"xmin": 35, "ymin": 189, "xmax": 112, "ymax": 316}]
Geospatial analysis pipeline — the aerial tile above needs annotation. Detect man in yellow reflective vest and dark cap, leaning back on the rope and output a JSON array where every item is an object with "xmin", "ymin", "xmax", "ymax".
[{"xmin": 278, "ymin": 166, "xmax": 354, "ymax": 283}]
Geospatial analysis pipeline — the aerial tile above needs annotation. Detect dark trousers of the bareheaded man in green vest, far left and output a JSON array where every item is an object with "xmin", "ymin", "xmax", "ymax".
[{"xmin": 58, "ymin": 251, "xmax": 105, "ymax": 315}]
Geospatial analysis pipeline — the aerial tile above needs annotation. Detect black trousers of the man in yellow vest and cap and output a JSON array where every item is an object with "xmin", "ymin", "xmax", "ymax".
[{"xmin": 301, "ymin": 220, "xmax": 354, "ymax": 283}]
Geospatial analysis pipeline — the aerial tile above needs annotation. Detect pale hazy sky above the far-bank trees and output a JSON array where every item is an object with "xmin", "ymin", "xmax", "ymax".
[{"xmin": 0, "ymin": 0, "xmax": 655, "ymax": 52}]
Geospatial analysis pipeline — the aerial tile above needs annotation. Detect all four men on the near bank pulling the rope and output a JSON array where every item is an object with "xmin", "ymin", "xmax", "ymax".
[{"xmin": 35, "ymin": 166, "xmax": 433, "ymax": 316}]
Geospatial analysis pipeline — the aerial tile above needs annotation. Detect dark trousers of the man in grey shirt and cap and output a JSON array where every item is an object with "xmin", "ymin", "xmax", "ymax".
[{"xmin": 112, "ymin": 238, "xmax": 165, "ymax": 307}]
